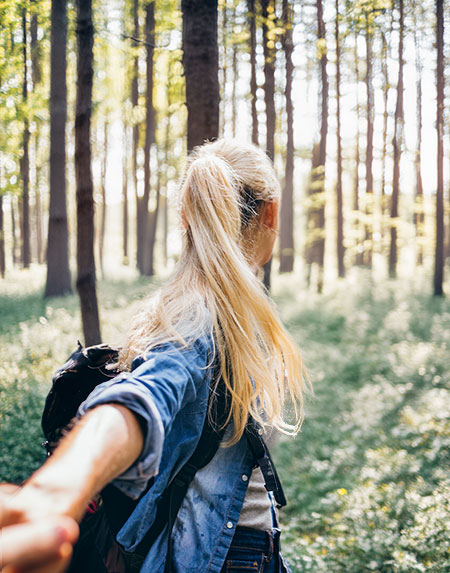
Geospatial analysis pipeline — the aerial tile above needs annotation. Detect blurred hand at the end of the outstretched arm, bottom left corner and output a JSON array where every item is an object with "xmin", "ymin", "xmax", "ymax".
[{"xmin": 0, "ymin": 486, "xmax": 78, "ymax": 573}]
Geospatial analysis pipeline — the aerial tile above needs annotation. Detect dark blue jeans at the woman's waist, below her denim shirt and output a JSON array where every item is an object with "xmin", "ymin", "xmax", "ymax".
[{"xmin": 221, "ymin": 527, "xmax": 291, "ymax": 573}]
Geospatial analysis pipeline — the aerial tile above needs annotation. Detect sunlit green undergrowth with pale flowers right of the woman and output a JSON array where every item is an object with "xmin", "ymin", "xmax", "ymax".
[{"xmin": 277, "ymin": 275, "xmax": 450, "ymax": 573}]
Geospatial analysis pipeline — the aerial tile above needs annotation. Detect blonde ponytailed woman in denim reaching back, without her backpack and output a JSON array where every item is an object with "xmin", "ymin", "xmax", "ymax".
[{"xmin": 0, "ymin": 140, "xmax": 304, "ymax": 573}]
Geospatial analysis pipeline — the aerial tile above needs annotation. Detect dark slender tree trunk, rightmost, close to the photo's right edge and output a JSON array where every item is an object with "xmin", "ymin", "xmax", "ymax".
[{"xmin": 433, "ymin": 0, "xmax": 444, "ymax": 296}]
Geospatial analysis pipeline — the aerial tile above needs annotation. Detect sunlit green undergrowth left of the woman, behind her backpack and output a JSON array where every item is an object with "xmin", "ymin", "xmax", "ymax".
[{"xmin": 0, "ymin": 268, "xmax": 155, "ymax": 483}]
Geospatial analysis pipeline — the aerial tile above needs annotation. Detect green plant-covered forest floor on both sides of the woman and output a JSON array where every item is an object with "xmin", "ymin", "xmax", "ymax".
[{"xmin": 0, "ymin": 267, "xmax": 450, "ymax": 573}]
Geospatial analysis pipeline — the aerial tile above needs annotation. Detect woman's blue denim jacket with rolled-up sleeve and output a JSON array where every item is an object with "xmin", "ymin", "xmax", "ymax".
[{"xmin": 78, "ymin": 336, "xmax": 253, "ymax": 573}]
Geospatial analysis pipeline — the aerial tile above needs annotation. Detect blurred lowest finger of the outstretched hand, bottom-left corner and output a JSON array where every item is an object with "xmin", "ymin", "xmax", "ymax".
[{"xmin": 0, "ymin": 516, "xmax": 78, "ymax": 568}]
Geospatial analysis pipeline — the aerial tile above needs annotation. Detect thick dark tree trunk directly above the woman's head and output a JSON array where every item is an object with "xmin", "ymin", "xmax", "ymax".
[{"xmin": 181, "ymin": 0, "xmax": 219, "ymax": 151}]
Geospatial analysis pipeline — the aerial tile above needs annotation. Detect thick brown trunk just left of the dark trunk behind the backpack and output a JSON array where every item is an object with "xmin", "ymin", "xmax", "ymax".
[{"xmin": 44, "ymin": 0, "xmax": 72, "ymax": 297}]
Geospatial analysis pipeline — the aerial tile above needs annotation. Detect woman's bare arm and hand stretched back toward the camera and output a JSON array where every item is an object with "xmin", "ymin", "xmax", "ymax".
[{"xmin": 0, "ymin": 404, "xmax": 143, "ymax": 572}]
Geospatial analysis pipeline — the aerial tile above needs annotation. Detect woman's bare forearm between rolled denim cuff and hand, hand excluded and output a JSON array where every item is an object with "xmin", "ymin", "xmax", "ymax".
[{"xmin": 18, "ymin": 404, "xmax": 143, "ymax": 520}]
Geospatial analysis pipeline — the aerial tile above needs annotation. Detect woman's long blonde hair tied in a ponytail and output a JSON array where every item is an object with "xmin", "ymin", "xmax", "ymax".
[{"xmin": 121, "ymin": 139, "xmax": 307, "ymax": 445}]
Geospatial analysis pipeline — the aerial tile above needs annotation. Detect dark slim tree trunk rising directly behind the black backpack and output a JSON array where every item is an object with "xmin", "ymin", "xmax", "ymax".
[{"xmin": 75, "ymin": 0, "xmax": 101, "ymax": 345}]
